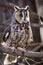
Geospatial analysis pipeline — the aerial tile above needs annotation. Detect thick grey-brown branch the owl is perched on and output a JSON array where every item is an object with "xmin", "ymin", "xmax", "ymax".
[{"xmin": 0, "ymin": 45, "xmax": 43, "ymax": 58}]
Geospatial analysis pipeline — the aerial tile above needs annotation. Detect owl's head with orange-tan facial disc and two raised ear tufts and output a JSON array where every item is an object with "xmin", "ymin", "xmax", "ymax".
[{"xmin": 14, "ymin": 5, "xmax": 30, "ymax": 23}]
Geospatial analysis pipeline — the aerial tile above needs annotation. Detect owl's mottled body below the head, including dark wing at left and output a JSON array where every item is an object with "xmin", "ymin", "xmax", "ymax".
[{"xmin": 3, "ymin": 24, "xmax": 33, "ymax": 46}]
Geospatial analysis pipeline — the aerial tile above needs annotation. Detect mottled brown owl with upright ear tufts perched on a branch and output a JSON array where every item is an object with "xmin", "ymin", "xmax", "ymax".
[{"xmin": 2, "ymin": 6, "xmax": 33, "ymax": 64}]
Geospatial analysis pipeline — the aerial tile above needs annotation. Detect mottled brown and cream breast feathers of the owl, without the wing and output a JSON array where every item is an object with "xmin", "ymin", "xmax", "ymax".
[{"xmin": 11, "ymin": 24, "xmax": 33, "ymax": 46}]
